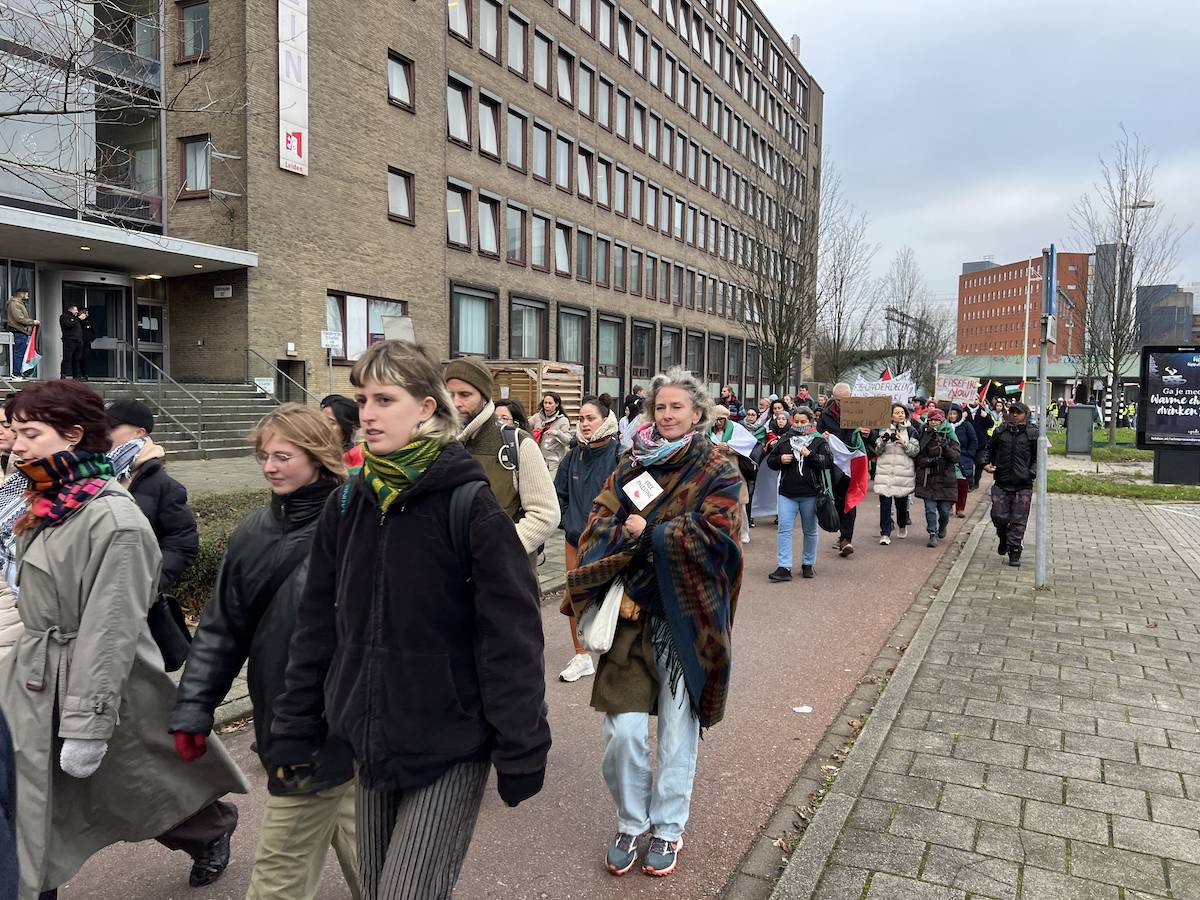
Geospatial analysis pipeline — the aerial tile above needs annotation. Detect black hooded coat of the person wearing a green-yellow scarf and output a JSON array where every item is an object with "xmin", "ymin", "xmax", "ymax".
[{"xmin": 271, "ymin": 442, "xmax": 550, "ymax": 790}]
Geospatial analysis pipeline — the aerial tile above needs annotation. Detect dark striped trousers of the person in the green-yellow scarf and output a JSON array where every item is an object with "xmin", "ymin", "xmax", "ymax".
[{"xmin": 358, "ymin": 761, "xmax": 491, "ymax": 900}]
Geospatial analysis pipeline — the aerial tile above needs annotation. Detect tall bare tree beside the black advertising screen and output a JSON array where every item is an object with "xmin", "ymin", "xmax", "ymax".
[{"xmin": 1070, "ymin": 126, "xmax": 1187, "ymax": 444}]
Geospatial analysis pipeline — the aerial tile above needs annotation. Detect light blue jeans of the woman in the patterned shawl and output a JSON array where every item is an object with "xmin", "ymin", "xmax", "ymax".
[{"xmin": 601, "ymin": 638, "xmax": 700, "ymax": 841}]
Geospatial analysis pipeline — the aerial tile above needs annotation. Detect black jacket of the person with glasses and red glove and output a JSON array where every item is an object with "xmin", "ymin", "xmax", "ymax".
[{"xmin": 168, "ymin": 479, "xmax": 354, "ymax": 794}]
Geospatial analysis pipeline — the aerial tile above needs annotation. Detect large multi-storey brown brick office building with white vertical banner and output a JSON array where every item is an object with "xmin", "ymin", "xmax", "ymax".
[{"xmin": 0, "ymin": 0, "xmax": 822, "ymax": 397}]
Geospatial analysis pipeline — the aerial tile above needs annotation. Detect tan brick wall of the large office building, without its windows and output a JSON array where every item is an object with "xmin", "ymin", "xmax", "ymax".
[{"xmin": 159, "ymin": 0, "xmax": 822, "ymax": 394}]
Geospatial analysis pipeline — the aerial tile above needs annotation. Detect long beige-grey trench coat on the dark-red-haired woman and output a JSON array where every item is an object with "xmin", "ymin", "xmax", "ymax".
[{"xmin": 0, "ymin": 481, "xmax": 246, "ymax": 900}]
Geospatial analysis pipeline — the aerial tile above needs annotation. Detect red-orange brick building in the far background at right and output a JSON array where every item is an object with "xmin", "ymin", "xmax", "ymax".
[{"xmin": 955, "ymin": 253, "xmax": 1088, "ymax": 362}]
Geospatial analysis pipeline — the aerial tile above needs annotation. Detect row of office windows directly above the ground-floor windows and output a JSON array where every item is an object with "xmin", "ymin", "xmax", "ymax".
[{"xmin": 446, "ymin": 180, "xmax": 745, "ymax": 319}]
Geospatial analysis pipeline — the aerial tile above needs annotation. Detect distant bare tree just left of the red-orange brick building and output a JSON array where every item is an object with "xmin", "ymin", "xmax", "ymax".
[{"xmin": 878, "ymin": 247, "xmax": 954, "ymax": 398}]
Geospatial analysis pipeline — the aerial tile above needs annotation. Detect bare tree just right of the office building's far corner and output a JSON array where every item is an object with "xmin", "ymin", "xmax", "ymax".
[{"xmin": 812, "ymin": 195, "xmax": 880, "ymax": 383}]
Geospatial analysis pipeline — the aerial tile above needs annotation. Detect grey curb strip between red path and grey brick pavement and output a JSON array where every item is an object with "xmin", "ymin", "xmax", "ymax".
[{"xmin": 770, "ymin": 504, "xmax": 989, "ymax": 900}]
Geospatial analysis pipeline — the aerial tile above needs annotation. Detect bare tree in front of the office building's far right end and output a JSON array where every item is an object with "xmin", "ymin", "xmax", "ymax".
[{"xmin": 726, "ymin": 138, "xmax": 825, "ymax": 389}]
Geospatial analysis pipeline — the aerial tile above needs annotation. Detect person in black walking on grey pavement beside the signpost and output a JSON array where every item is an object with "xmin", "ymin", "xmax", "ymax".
[{"xmin": 988, "ymin": 403, "xmax": 1040, "ymax": 565}]
